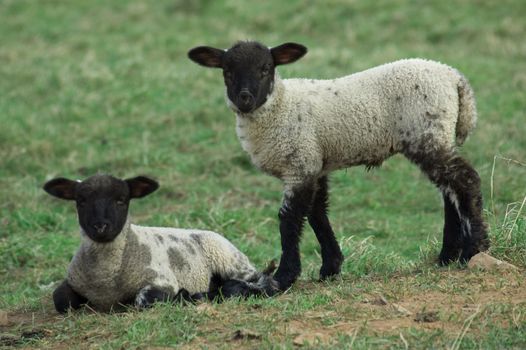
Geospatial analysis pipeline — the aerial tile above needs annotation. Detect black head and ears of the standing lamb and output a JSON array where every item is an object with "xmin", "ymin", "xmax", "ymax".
[{"xmin": 188, "ymin": 41, "xmax": 307, "ymax": 113}]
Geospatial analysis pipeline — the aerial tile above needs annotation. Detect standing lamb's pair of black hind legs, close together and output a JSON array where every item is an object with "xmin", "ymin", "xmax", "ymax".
[{"xmin": 406, "ymin": 146, "xmax": 489, "ymax": 264}]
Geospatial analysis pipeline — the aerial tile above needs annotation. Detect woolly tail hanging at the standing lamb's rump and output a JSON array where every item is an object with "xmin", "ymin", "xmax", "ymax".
[{"xmin": 455, "ymin": 74, "xmax": 477, "ymax": 146}]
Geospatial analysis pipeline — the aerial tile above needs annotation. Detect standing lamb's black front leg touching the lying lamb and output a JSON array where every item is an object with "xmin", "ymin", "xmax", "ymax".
[{"xmin": 274, "ymin": 181, "xmax": 314, "ymax": 290}]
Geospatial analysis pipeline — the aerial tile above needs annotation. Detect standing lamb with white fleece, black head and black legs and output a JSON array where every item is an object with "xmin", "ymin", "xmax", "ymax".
[{"xmin": 188, "ymin": 41, "xmax": 489, "ymax": 289}]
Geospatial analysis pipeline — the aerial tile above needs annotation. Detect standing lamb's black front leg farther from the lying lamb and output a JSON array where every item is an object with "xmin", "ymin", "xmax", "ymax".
[{"xmin": 307, "ymin": 176, "xmax": 343, "ymax": 280}]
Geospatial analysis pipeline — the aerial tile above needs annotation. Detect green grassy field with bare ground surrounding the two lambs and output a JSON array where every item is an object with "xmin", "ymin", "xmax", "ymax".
[{"xmin": 0, "ymin": 0, "xmax": 526, "ymax": 349}]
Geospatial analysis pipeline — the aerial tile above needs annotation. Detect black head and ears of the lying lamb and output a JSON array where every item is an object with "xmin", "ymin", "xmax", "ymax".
[{"xmin": 44, "ymin": 175, "xmax": 159, "ymax": 243}]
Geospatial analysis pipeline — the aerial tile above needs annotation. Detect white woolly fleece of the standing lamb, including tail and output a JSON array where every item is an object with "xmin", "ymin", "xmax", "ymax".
[{"xmin": 236, "ymin": 59, "xmax": 476, "ymax": 190}]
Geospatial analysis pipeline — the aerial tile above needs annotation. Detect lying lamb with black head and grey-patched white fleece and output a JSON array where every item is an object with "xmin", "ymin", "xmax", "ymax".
[{"xmin": 44, "ymin": 175, "xmax": 277, "ymax": 312}]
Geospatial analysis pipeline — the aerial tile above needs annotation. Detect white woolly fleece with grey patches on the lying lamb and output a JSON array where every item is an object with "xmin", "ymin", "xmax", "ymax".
[{"xmin": 67, "ymin": 217, "xmax": 259, "ymax": 310}]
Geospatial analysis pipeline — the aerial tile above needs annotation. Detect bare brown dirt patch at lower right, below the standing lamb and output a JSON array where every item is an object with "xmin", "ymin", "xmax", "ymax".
[{"xmin": 287, "ymin": 269, "xmax": 526, "ymax": 345}]
